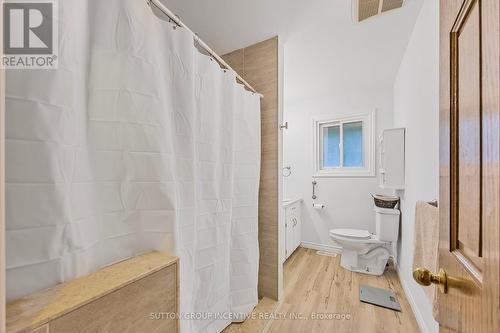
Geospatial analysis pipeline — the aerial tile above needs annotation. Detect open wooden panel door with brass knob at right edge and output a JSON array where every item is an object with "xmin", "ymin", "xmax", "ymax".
[{"xmin": 440, "ymin": 0, "xmax": 500, "ymax": 332}]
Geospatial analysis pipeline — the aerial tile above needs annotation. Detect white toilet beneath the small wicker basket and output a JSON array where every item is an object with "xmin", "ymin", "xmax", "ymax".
[{"xmin": 330, "ymin": 207, "xmax": 400, "ymax": 275}]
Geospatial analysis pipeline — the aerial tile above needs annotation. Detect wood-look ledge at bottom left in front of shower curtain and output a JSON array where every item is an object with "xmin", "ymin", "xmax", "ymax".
[{"xmin": 7, "ymin": 252, "xmax": 179, "ymax": 333}]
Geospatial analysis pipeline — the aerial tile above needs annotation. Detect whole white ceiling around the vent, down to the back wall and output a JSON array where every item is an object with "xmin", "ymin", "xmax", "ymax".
[{"xmin": 162, "ymin": 0, "xmax": 424, "ymax": 98}]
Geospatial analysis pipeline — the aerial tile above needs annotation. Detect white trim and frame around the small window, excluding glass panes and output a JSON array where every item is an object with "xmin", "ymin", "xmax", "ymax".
[{"xmin": 313, "ymin": 110, "xmax": 376, "ymax": 178}]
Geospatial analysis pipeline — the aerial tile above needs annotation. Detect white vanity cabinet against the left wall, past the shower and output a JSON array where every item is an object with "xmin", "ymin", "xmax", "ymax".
[{"xmin": 283, "ymin": 199, "xmax": 302, "ymax": 260}]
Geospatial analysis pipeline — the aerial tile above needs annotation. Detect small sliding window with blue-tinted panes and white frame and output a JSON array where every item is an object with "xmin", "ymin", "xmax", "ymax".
[{"xmin": 314, "ymin": 113, "xmax": 375, "ymax": 177}]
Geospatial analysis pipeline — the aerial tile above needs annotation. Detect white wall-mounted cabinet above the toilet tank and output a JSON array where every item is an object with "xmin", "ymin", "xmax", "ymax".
[{"xmin": 379, "ymin": 128, "xmax": 405, "ymax": 190}]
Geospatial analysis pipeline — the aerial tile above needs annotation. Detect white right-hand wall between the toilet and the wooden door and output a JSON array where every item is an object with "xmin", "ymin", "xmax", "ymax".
[{"xmin": 394, "ymin": 0, "xmax": 439, "ymax": 332}]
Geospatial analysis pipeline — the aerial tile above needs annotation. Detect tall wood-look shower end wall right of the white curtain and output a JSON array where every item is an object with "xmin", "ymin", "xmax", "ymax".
[{"xmin": 222, "ymin": 37, "xmax": 279, "ymax": 300}]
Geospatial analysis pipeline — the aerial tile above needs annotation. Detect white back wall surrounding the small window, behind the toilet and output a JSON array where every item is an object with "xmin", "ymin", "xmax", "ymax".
[{"xmin": 283, "ymin": 87, "xmax": 393, "ymax": 245}]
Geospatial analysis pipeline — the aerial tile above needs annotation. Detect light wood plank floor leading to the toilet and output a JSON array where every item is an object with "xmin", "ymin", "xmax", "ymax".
[{"xmin": 224, "ymin": 248, "xmax": 419, "ymax": 333}]
